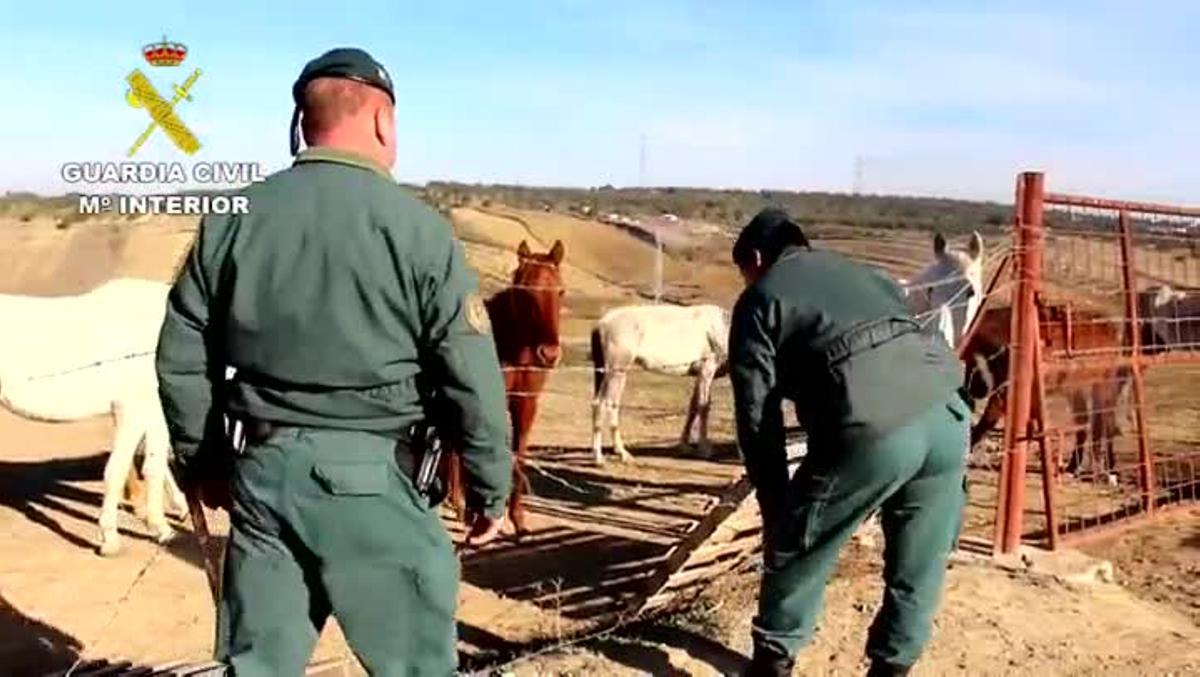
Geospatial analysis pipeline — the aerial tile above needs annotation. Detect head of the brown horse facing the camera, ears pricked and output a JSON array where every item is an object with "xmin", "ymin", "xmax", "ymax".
[{"xmin": 509, "ymin": 240, "xmax": 565, "ymax": 367}]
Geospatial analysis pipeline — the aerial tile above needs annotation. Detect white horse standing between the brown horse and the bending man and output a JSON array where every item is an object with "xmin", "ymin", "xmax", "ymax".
[{"xmin": 592, "ymin": 305, "xmax": 730, "ymax": 465}]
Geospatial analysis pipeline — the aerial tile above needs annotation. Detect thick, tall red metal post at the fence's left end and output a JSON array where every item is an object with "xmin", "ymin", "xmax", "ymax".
[{"xmin": 997, "ymin": 172, "xmax": 1044, "ymax": 553}]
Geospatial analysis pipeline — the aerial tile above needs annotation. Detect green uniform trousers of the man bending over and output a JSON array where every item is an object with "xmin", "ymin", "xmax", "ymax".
[{"xmin": 752, "ymin": 395, "xmax": 970, "ymax": 665}]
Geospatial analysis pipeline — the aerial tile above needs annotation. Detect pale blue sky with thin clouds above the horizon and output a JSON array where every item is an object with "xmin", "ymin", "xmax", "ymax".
[{"xmin": 0, "ymin": 0, "xmax": 1200, "ymax": 204}]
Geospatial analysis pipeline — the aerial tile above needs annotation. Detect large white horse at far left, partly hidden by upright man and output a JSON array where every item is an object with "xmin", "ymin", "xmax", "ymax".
[{"xmin": 0, "ymin": 278, "xmax": 186, "ymax": 556}]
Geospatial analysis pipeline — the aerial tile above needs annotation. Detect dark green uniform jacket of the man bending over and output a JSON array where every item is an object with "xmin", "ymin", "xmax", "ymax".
[{"xmin": 730, "ymin": 247, "xmax": 962, "ymax": 516}]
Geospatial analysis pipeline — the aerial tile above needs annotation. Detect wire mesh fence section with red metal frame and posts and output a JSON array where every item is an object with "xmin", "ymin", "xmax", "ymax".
[{"xmin": 984, "ymin": 173, "xmax": 1200, "ymax": 551}]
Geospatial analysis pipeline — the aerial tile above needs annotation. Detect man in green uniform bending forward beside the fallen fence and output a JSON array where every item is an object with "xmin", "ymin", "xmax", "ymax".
[{"xmin": 730, "ymin": 209, "xmax": 970, "ymax": 676}]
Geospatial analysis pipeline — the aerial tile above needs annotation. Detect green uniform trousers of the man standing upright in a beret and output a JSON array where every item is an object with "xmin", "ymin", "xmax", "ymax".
[{"xmin": 216, "ymin": 429, "xmax": 458, "ymax": 677}]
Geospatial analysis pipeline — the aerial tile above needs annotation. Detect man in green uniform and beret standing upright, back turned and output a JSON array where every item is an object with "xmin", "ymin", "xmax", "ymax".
[{"xmin": 157, "ymin": 49, "xmax": 511, "ymax": 677}]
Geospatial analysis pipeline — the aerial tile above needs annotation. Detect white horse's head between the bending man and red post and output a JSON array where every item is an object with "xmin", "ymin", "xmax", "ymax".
[{"xmin": 901, "ymin": 232, "xmax": 983, "ymax": 346}]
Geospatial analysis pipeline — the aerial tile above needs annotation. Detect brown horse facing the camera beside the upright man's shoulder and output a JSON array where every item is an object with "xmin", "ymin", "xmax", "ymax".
[{"xmin": 443, "ymin": 240, "xmax": 564, "ymax": 537}]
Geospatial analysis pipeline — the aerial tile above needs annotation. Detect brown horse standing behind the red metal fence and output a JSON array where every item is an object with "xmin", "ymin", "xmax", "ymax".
[{"xmin": 962, "ymin": 305, "xmax": 1130, "ymax": 478}]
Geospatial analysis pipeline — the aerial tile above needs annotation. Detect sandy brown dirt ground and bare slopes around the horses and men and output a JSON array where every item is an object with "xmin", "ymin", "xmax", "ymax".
[{"xmin": 0, "ymin": 210, "xmax": 1200, "ymax": 675}]
